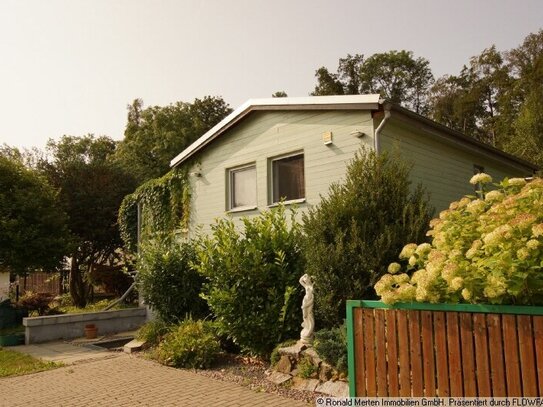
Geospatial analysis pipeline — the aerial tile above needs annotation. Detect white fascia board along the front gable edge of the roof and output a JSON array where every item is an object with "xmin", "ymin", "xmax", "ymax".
[{"xmin": 170, "ymin": 94, "xmax": 383, "ymax": 167}]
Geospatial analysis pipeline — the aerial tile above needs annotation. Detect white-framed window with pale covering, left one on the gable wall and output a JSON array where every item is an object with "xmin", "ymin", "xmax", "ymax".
[{"xmin": 227, "ymin": 164, "xmax": 257, "ymax": 210}]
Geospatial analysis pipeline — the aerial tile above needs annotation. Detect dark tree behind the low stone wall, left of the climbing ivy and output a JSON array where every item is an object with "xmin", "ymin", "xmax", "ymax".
[{"xmin": 40, "ymin": 135, "xmax": 135, "ymax": 307}]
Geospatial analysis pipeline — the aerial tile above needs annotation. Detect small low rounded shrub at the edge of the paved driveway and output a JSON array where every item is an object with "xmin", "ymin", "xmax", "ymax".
[{"xmin": 157, "ymin": 319, "xmax": 220, "ymax": 369}]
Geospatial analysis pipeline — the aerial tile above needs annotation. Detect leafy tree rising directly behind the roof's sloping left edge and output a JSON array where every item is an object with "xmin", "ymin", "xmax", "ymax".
[{"xmin": 115, "ymin": 96, "xmax": 231, "ymax": 184}]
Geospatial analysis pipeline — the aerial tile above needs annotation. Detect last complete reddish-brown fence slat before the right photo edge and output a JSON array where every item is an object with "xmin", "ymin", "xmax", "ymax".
[{"xmin": 517, "ymin": 315, "xmax": 538, "ymax": 397}]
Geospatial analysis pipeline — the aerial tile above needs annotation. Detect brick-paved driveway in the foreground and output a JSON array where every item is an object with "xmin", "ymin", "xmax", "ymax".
[{"xmin": 0, "ymin": 353, "xmax": 307, "ymax": 407}]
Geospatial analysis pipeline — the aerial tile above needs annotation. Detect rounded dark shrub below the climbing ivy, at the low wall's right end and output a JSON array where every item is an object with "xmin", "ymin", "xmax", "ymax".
[{"xmin": 138, "ymin": 234, "xmax": 208, "ymax": 323}]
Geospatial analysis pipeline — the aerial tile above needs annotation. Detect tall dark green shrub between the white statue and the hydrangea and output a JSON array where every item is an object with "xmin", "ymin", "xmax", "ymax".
[{"xmin": 303, "ymin": 151, "xmax": 430, "ymax": 328}]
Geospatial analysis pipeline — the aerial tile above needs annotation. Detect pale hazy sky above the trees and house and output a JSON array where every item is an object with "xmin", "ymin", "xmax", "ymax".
[{"xmin": 0, "ymin": 0, "xmax": 543, "ymax": 148}]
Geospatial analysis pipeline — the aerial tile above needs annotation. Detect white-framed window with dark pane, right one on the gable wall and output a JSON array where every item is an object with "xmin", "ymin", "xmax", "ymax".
[{"xmin": 270, "ymin": 152, "xmax": 305, "ymax": 204}]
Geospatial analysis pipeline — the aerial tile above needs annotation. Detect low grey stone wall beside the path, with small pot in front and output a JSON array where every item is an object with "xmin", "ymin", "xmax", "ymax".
[{"xmin": 23, "ymin": 308, "xmax": 147, "ymax": 345}]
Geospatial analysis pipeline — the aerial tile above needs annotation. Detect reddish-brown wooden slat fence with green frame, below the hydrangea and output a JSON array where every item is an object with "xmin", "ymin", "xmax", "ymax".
[{"xmin": 347, "ymin": 301, "xmax": 543, "ymax": 397}]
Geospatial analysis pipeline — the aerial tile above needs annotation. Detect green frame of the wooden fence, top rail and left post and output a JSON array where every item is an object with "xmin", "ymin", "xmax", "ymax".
[{"xmin": 347, "ymin": 300, "xmax": 543, "ymax": 397}]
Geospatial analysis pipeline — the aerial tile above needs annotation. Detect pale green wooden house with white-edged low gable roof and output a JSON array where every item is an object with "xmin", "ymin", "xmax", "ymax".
[{"xmin": 171, "ymin": 95, "xmax": 537, "ymax": 231}]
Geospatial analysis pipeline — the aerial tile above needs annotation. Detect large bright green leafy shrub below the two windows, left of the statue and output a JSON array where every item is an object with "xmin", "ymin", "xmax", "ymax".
[{"xmin": 195, "ymin": 205, "xmax": 303, "ymax": 356}]
